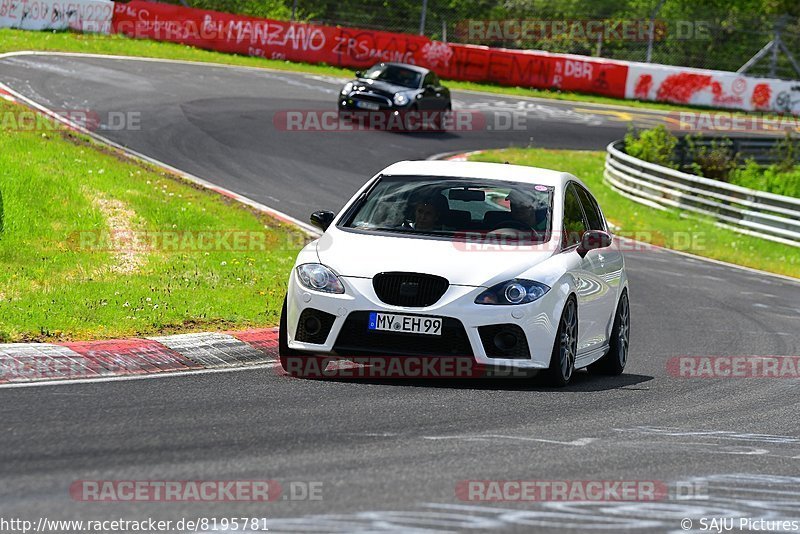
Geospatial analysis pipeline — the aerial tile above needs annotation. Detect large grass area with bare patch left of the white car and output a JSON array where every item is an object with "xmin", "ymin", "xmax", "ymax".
[{"xmin": 0, "ymin": 101, "xmax": 305, "ymax": 341}]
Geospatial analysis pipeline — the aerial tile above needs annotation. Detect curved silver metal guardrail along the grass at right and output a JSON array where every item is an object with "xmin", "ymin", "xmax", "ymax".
[{"xmin": 604, "ymin": 141, "xmax": 800, "ymax": 251}]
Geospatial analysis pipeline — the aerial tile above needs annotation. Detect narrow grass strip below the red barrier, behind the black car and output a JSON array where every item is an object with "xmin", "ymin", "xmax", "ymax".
[{"xmin": 0, "ymin": 29, "xmax": 764, "ymax": 111}]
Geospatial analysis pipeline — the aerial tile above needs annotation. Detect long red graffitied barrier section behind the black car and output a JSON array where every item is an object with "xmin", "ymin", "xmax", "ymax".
[{"xmin": 113, "ymin": 0, "xmax": 628, "ymax": 98}]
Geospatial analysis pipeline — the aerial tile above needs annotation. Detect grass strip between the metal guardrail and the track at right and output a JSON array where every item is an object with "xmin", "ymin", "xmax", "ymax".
[{"xmin": 470, "ymin": 148, "xmax": 800, "ymax": 278}]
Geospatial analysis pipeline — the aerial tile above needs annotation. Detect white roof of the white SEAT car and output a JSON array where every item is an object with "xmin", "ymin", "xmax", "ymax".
[{"xmin": 381, "ymin": 160, "xmax": 585, "ymax": 188}]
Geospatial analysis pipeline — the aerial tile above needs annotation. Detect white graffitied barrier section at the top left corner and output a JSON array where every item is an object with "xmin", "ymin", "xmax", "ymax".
[{"xmin": 0, "ymin": 0, "xmax": 114, "ymax": 33}]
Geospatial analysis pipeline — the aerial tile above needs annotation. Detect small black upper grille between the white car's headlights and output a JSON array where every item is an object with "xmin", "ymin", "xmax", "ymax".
[{"xmin": 372, "ymin": 273, "xmax": 450, "ymax": 308}]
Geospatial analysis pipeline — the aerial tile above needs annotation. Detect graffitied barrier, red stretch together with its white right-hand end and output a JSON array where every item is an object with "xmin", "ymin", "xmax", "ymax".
[{"xmin": 112, "ymin": 0, "xmax": 800, "ymax": 115}]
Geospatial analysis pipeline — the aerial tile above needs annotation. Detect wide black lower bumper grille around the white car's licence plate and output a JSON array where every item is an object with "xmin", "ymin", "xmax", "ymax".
[{"xmin": 333, "ymin": 311, "xmax": 472, "ymax": 356}]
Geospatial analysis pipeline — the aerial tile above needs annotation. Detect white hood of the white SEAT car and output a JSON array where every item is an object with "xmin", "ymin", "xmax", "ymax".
[{"xmin": 317, "ymin": 229, "xmax": 553, "ymax": 287}]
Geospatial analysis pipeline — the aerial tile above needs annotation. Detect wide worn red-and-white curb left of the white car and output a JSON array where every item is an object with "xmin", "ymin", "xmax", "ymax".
[{"xmin": 0, "ymin": 328, "xmax": 278, "ymax": 387}]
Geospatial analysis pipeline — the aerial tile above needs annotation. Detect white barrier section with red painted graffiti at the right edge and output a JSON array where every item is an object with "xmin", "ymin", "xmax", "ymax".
[{"xmin": 625, "ymin": 63, "xmax": 800, "ymax": 115}]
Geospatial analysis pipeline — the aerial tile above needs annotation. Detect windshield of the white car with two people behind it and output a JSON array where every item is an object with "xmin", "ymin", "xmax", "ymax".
[{"xmin": 340, "ymin": 176, "xmax": 554, "ymax": 242}]
